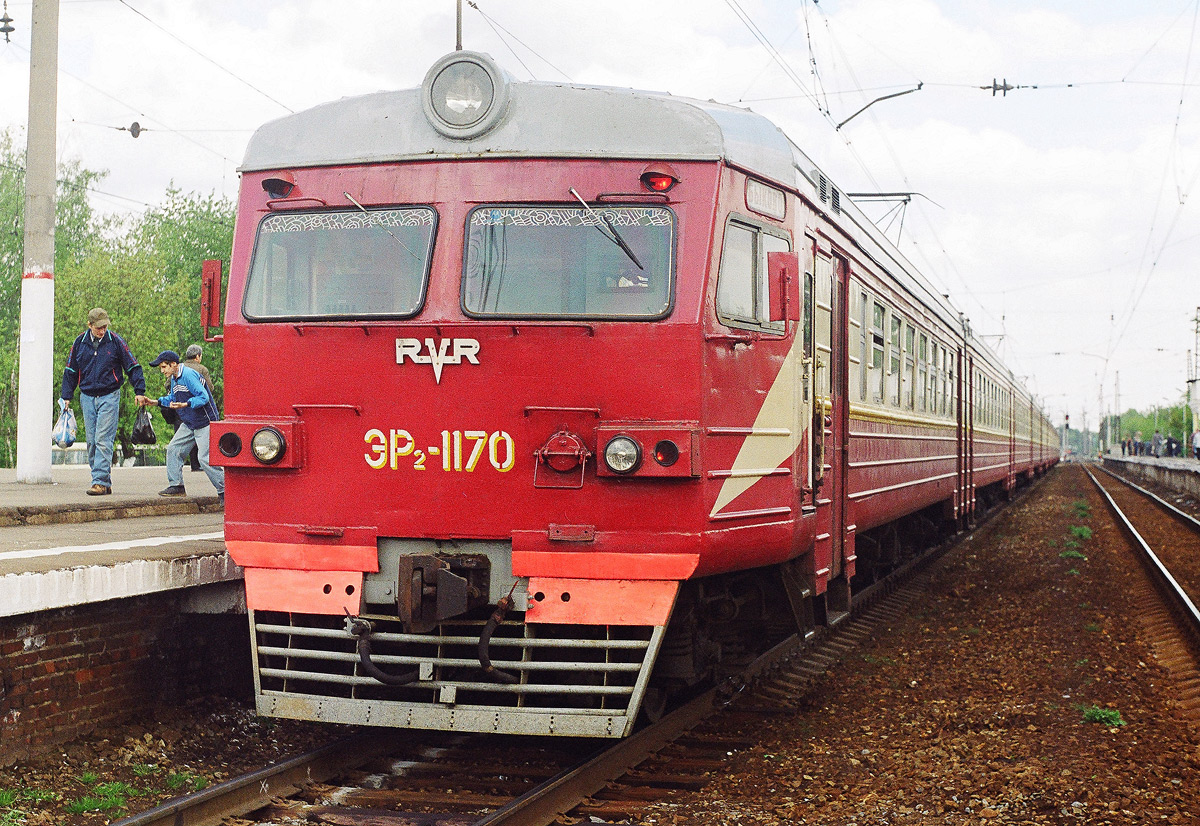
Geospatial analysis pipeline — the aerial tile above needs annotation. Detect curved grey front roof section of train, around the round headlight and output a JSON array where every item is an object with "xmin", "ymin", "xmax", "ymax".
[{"xmin": 241, "ymin": 83, "xmax": 796, "ymax": 188}]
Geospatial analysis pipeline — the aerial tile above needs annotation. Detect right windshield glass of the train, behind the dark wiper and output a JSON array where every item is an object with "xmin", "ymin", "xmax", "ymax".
[{"xmin": 462, "ymin": 207, "xmax": 676, "ymax": 318}]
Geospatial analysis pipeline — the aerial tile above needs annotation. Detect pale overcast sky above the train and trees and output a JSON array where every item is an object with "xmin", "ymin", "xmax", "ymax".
[{"xmin": 0, "ymin": 0, "xmax": 1200, "ymax": 426}]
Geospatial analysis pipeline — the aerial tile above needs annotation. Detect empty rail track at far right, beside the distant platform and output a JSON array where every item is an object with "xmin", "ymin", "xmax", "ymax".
[{"xmin": 1085, "ymin": 468, "xmax": 1200, "ymax": 725}]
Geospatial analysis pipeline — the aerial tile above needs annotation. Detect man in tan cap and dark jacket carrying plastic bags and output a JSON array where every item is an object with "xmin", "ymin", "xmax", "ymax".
[{"xmin": 59, "ymin": 307, "xmax": 149, "ymax": 496}]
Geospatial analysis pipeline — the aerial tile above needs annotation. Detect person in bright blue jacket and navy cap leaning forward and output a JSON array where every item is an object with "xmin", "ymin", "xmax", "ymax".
[{"xmin": 144, "ymin": 349, "xmax": 224, "ymax": 505}]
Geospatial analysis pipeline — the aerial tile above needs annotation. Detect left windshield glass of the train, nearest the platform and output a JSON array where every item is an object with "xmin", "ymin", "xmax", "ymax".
[{"xmin": 244, "ymin": 207, "xmax": 437, "ymax": 319}]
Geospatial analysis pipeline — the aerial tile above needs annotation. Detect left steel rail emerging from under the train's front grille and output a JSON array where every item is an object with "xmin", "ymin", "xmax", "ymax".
[{"xmin": 112, "ymin": 732, "xmax": 396, "ymax": 826}]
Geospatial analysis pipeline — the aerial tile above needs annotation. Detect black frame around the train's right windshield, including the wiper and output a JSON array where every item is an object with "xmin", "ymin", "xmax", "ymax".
[{"xmin": 458, "ymin": 200, "xmax": 680, "ymax": 323}]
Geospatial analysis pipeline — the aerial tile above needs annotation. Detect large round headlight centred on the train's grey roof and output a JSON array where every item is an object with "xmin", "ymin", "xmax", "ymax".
[{"xmin": 421, "ymin": 52, "xmax": 509, "ymax": 140}]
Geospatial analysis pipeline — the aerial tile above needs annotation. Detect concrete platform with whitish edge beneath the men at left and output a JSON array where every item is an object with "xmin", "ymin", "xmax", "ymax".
[{"xmin": 0, "ymin": 465, "xmax": 241, "ymax": 617}]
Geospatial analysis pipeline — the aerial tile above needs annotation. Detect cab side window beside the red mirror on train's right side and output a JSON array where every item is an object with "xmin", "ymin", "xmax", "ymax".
[{"xmin": 716, "ymin": 220, "xmax": 792, "ymax": 333}]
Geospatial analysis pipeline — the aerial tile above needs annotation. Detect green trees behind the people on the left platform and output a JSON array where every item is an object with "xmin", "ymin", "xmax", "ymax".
[{"xmin": 0, "ymin": 132, "xmax": 234, "ymax": 467}]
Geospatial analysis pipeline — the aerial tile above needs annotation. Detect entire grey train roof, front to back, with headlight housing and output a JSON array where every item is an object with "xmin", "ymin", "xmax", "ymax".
[{"xmin": 241, "ymin": 52, "xmax": 1032, "ymax": 405}]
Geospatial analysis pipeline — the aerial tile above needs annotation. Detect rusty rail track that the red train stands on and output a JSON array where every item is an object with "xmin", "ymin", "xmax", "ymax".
[{"xmin": 113, "ymin": 480, "xmax": 1041, "ymax": 826}]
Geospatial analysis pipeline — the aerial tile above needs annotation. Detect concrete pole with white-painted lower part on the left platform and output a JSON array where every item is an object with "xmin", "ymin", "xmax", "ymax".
[{"xmin": 17, "ymin": 0, "xmax": 59, "ymax": 484}]
